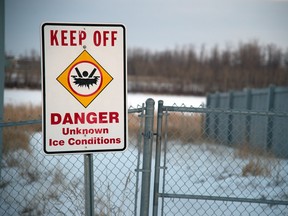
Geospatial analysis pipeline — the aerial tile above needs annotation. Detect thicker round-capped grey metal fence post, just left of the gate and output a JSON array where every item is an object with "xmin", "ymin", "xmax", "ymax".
[{"xmin": 140, "ymin": 98, "xmax": 155, "ymax": 216}]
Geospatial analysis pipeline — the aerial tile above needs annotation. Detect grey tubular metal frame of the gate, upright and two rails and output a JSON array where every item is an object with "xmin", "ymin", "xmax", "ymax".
[{"xmin": 151, "ymin": 100, "xmax": 288, "ymax": 216}]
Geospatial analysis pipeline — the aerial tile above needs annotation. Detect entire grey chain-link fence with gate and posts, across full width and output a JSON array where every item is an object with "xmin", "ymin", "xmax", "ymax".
[{"xmin": 0, "ymin": 99, "xmax": 288, "ymax": 216}]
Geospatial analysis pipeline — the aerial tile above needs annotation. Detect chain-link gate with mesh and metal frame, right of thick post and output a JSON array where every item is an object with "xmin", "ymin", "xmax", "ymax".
[{"xmin": 153, "ymin": 101, "xmax": 288, "ymax": 216}]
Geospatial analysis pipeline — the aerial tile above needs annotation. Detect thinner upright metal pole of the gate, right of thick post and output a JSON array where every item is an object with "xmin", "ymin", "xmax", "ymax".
[{"xmin": 153, "ymin": 100, "xmax": 163, "ymax": 216}]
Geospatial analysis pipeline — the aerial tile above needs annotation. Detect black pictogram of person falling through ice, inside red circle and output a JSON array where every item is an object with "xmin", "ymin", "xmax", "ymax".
[{"xmin": 71, "ymin": 67, "xmax": 100, "ymax": 89}]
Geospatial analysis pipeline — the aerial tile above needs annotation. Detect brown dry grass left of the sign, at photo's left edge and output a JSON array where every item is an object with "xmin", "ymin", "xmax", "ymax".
[{"xmin": 3, "ymin": 104, "xmax": 42, "ymax": 154}]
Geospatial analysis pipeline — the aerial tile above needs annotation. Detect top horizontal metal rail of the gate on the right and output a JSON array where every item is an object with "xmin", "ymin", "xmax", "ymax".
[{"xmin": 163, "ymin": 106, "xmax": 288, "ymax": 117}]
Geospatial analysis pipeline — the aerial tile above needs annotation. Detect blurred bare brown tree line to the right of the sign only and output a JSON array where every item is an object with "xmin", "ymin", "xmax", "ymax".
[{"xmin": 128, "ymin": 41, "xmax": 288, "ymax": 94}]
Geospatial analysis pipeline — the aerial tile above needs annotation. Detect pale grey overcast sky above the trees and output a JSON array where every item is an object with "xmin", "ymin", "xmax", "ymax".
[{"xmin": 5, "ymin": 0, "xmax": 288, "ymax": 55}]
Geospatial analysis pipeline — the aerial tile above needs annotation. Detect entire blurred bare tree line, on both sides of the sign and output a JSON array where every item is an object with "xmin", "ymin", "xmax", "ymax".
[{"xmin": 5, "ymin": 41, "xmax": 288, "ymax": 95}]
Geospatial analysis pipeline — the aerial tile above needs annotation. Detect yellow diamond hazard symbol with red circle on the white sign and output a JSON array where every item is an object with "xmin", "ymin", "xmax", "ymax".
[{"xmin": 57, "ymin": 50, "xmax": 113, "ymax": 108}]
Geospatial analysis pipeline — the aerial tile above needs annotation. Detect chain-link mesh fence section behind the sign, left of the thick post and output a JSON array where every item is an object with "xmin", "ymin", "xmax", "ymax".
[{"xmin": 0, "ymin": 104, "xmax": 144, "ymax": 216}]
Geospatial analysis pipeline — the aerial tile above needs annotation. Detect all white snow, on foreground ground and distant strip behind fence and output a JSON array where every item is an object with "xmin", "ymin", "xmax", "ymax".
[{"xmin": 0, "ymin": 89, "xmax": 288, "ymax": 216}]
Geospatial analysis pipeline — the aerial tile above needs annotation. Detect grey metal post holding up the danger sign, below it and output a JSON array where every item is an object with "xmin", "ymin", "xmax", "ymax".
[{"xmin": 84, "ymin": 154, "xmax": 94, "ymax": 216}]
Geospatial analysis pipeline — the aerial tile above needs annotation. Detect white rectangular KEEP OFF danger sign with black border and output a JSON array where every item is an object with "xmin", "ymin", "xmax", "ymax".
[{"xmin": 41, "ymin": 23, "xmax": 127, "ymax": 154}]
